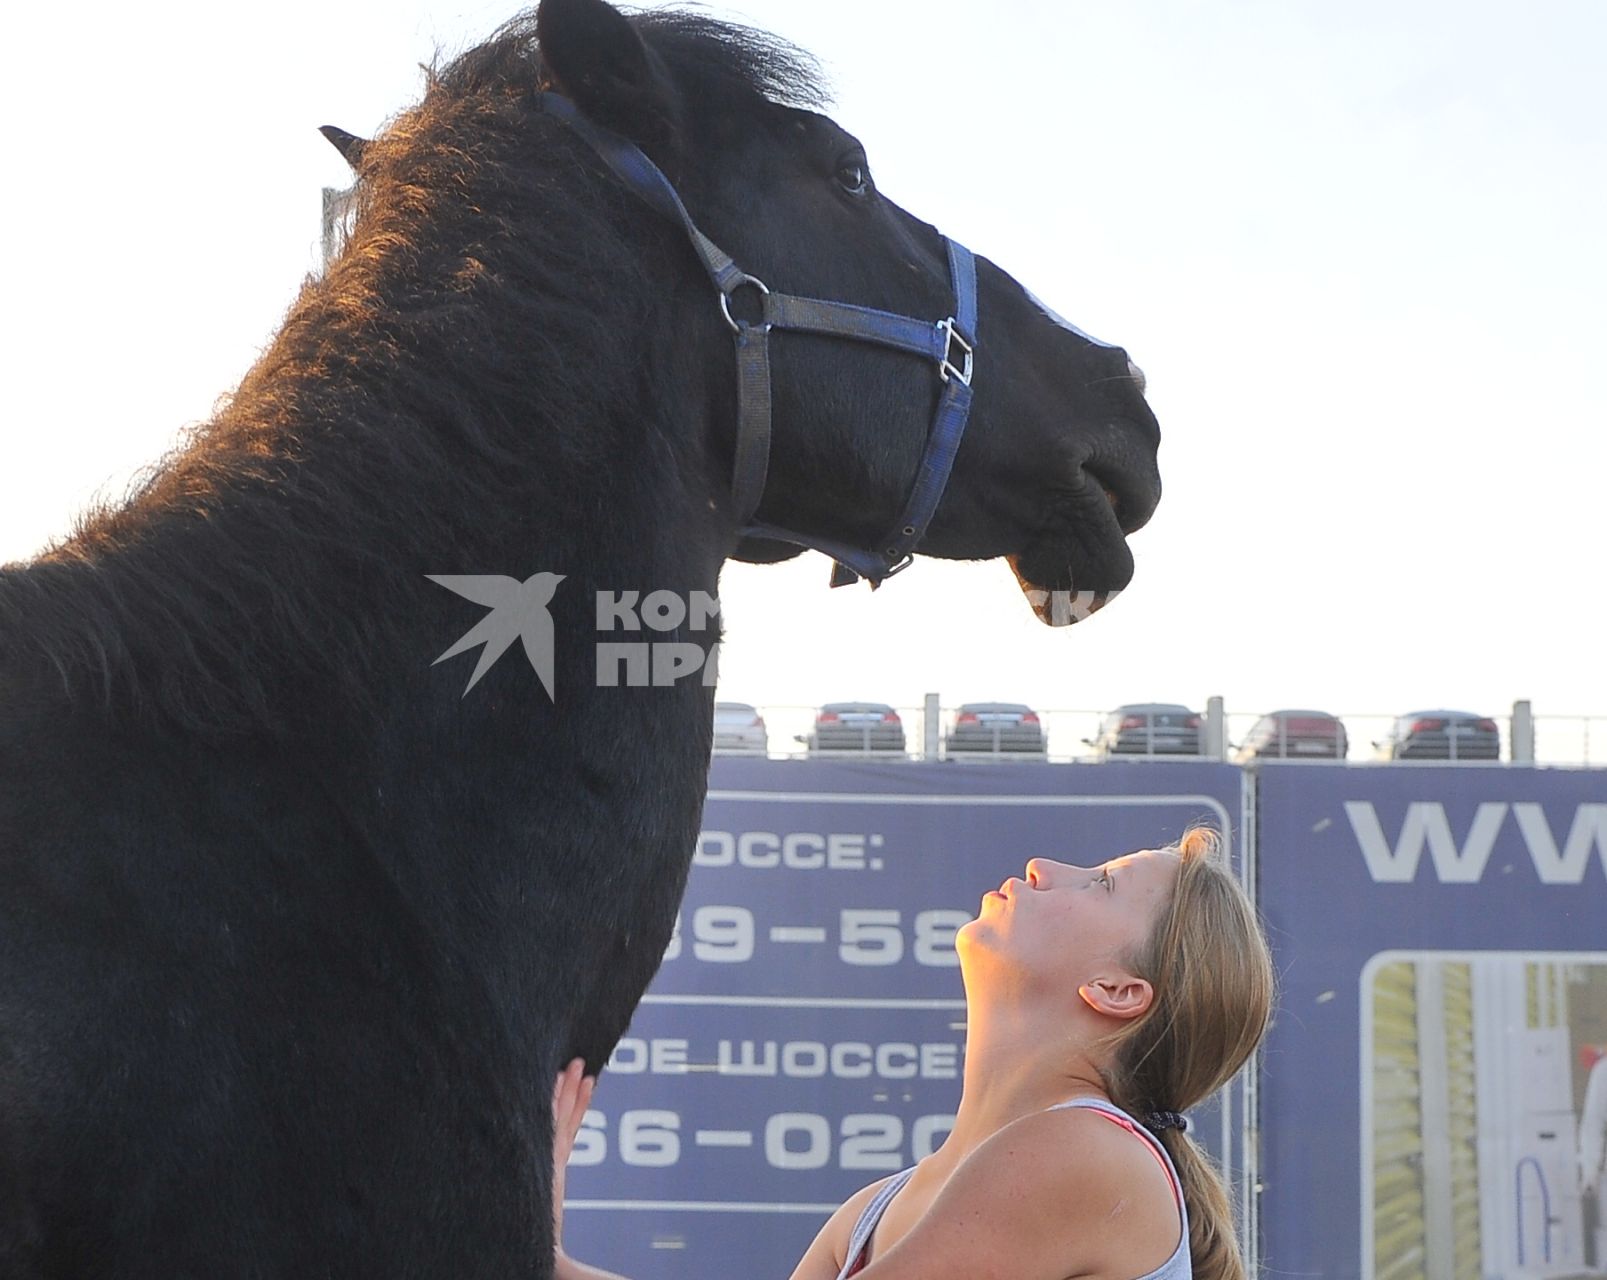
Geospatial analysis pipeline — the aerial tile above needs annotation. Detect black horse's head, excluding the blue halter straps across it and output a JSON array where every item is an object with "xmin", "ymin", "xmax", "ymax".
[{"xmin": 538, "ymin": 0, "xmax": 1160, "ymax": 623}]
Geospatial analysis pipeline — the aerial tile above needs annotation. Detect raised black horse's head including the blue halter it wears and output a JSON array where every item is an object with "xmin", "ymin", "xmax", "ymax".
[{"xmin": 326, "ymin": 0, "xmax": 1160, "ymax": 625}]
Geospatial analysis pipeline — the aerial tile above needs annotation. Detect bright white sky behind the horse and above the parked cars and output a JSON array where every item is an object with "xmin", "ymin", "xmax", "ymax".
[{"xmin": 0, "ymin": 0, "xmax": 1607, "ymax": 745}]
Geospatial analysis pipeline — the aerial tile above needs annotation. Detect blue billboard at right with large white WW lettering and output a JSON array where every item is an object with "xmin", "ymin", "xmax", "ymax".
[{"xmin": 1255, "ymin": 764, "xmax": 1607, "ymax": 1280}]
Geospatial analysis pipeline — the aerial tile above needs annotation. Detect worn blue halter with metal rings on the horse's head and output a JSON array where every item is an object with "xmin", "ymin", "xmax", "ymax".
[{"xmin": 540, "ymin": 92, "xmax": 977, "ymax": 588}]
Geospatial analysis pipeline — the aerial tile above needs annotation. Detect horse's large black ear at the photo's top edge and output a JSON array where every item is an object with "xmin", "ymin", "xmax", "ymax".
[{"xmin": 535, "ymin": 0, "xmax": 673, "ymax": 145}]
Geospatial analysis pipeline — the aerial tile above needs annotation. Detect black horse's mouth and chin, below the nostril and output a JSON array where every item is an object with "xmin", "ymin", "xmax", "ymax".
[{"xmin": 1006, "ymin": 467, "xmax": 1154, "ymax": 626}]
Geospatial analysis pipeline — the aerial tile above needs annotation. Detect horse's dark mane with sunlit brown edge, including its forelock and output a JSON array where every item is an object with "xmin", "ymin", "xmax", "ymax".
[{"xmin": 0, "ymin": 11, "xmax": 826, "ymax": 734}]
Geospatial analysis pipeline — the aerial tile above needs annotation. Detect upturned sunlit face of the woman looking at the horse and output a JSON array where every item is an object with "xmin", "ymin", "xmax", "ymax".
[{"xmin": 958, "ymin": 850, "xmax": 1178, "ymax": 991}]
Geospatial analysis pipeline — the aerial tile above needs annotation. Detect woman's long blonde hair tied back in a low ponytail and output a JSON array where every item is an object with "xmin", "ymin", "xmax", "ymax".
[{"xmin": 1106, "ymin": 827, "xmax": 1274, "ymax": 1280}]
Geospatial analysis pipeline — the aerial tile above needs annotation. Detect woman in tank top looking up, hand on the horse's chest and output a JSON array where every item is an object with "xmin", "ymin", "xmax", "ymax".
[{"xmin": 553, "ymin": 829, "xmax": 1273, "ymax": 1280}]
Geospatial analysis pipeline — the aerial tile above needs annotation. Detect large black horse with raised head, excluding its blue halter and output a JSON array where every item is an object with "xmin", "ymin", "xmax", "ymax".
[{"xmin": 0, "ymin": 0, "xmax": 1159, "ymax": 1280}]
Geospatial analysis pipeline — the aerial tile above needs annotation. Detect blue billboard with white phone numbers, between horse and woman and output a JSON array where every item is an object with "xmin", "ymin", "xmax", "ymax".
[{"xmin": 566, "ymin": 760, "xmax": 1244, "ymax": 1277}]
